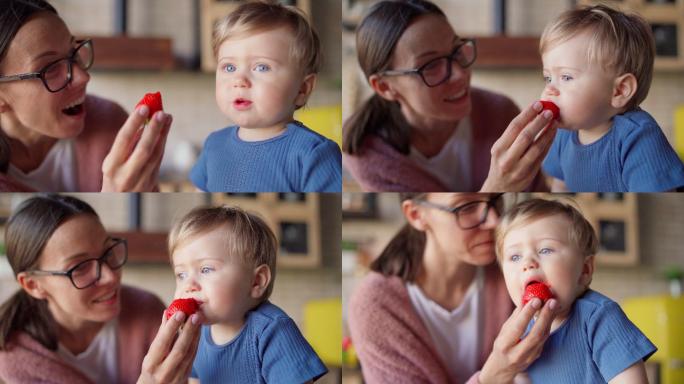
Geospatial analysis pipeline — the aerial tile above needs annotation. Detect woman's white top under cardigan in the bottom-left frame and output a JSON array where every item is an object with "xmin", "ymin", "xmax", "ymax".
[{"xmin": 57, "ymin": 318, "xmax": 119, "ymax": 384}]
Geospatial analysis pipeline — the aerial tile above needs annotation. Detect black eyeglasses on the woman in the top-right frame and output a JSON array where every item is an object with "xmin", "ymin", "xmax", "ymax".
[{"xmin": 380, "ymin": 39, "xmax": 477, "ymax": 87}]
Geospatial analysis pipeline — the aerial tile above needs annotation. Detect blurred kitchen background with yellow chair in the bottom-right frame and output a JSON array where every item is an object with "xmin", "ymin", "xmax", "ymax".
[{"xmin": 342, "ymin": 193, "xmax": 684, "ymax": 384}]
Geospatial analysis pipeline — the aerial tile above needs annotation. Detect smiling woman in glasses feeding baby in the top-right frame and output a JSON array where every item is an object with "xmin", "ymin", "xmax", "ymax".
[{"xmin": 342, "ymin": 0, "xmax": 557, "ymax": 192}]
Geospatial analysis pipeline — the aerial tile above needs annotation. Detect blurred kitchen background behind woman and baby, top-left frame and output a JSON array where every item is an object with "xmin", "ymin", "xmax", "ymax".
[{"xmin": 49, "ymin": 0, "xmax": 342, "ymax": 192}]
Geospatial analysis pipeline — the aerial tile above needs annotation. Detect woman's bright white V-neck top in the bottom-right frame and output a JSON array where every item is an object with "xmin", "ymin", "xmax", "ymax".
[{"xmin": 406, "ymin": 267, "xmax": 484, "ymax": 383}]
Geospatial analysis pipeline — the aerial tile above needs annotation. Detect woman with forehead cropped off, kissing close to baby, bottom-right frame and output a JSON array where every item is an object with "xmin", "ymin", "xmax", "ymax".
[{"xmin": 349, "ymin": 193, "xmax": 556, "ymax": 384}]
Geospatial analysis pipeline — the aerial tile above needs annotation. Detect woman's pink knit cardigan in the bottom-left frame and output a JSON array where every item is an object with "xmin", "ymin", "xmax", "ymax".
[{"xmin": 0, "ymin": 286, "xmax": 164, "ymax": 384}]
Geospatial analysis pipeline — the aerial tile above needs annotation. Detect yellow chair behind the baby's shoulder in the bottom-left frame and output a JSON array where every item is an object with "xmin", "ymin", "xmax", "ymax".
[{"xmin": 304, "ymin": 298, "xmax": 342, "ymax": 367}]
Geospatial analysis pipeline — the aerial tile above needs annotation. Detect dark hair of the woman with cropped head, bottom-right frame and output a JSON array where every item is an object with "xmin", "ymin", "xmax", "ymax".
[{"xmin": 370, "ymin": 193, "xmax": 425, "ymax": 282}]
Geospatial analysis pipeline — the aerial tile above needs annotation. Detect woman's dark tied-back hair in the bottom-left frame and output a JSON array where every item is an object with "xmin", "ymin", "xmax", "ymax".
[{"xmin": 0, "ymin": 195, "xmax": 98, "ymax": 351}]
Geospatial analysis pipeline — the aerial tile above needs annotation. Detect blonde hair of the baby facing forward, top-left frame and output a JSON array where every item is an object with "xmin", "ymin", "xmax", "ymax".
[{"xmin": 212, "ymin": 0, "xmax": 321, "ymax": 75}]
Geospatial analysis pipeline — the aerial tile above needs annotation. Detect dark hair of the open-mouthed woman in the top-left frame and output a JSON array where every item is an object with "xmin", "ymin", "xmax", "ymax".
[{"xmin": 0, "ymin": 0, "xmax": 57, "ymax": 173}]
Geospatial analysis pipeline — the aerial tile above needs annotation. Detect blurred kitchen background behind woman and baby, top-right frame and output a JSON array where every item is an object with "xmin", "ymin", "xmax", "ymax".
[{"xmin": 342, "ymin": 0, "xmax": 684, "ymax": 192}]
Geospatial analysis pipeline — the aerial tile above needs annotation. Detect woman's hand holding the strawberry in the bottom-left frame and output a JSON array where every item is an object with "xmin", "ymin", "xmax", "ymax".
[{"xmin": 138, "ymin": 311, "xmax": 201, "ymax": 384}]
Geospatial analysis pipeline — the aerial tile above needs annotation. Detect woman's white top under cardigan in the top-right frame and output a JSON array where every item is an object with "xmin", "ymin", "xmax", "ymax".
[{"xmin": 409, "ymin": 116, "xmax": 474, "ymax": 192}]
